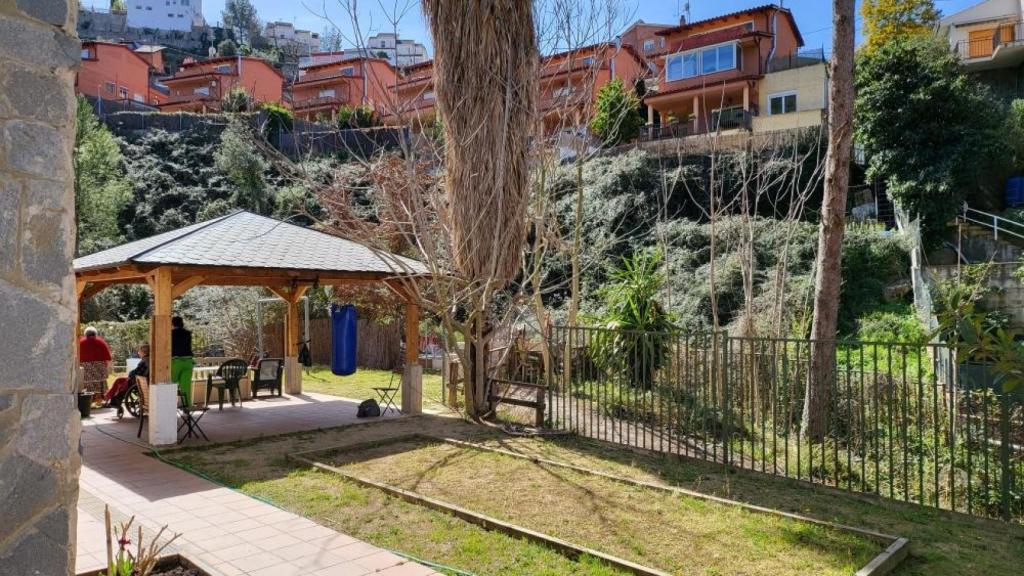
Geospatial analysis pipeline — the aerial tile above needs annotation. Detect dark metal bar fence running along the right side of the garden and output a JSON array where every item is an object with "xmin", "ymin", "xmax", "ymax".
[{"xmin": 545, "ymin": 327, "xmax": 1024, "ymax": 522}]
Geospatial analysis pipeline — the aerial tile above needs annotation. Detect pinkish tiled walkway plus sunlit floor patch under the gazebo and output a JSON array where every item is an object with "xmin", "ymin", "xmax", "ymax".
[{"xmin": 77, "ymin": 394, "xmax": 436, "ymax": 576}]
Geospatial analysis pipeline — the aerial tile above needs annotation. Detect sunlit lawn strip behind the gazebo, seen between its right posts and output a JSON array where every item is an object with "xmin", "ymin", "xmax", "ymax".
[{"xmin": 302, "ymin": 366, "xmax": 446, "ymax": 410}]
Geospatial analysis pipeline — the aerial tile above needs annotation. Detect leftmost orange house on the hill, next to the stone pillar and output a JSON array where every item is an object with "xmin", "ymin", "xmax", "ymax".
[{"xmin": 75, "ymin": 41, "xmax": 163, "ymax": 105}]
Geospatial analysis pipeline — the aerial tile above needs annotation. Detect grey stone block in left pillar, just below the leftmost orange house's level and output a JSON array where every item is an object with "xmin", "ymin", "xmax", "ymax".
[{"xmin": 0, "ymin": 121, "xmax": 72, "ymax": 180}]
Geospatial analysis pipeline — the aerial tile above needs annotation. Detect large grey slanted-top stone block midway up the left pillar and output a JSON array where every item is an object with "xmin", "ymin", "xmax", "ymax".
[{"xmin": 0, "ymin": 280, "xmax": 75, "ymax": 393}]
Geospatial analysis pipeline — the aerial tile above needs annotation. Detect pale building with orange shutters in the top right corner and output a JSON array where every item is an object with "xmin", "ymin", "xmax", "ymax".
[{"xmin": 939, "ymin": 0, "xmax": 1024, "ymax": 71}]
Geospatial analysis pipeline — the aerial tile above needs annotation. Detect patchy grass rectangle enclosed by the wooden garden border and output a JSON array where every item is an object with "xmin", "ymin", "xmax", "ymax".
[{"xmin": 314, "ymin": 440, "xmax": 883, "ymax": 576}]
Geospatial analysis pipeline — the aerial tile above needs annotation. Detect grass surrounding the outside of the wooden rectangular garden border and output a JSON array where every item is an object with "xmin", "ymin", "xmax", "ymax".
[{"xmin": 159, "ymin": 415, "xmax": 1024, "ymax": 576}]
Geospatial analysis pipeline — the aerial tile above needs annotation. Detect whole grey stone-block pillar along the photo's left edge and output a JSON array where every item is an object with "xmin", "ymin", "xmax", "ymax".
[{"xmin": 0, "ymin": 0, "xmax": 81, "ymax": 576}]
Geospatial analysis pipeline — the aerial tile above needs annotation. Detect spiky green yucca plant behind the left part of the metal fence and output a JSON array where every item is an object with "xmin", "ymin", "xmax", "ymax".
[{"xmin": 591, "ymin": 250, "xmax": 676, "ymax": 388}]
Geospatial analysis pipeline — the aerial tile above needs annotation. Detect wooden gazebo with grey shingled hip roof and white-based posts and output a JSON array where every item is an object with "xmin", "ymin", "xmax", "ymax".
[{"xmin": 74, "ymin": 210, "xmax": 427, "ymax": 444}]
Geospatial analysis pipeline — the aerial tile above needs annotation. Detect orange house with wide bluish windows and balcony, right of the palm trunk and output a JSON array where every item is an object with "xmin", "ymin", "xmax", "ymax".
[{"xmin": 644, "ymin": 4, "xmax": 804, "ymax": 135}]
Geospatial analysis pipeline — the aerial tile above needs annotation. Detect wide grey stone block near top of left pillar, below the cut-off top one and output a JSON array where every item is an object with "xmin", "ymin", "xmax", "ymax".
[{"xmin": 0, "ymin": 13, "xmax": 82, "ymax": 70}]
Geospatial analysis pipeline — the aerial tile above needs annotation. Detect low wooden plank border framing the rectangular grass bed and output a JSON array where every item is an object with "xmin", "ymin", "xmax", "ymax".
[{"xmin": 287, "ymin": 433, "xmax": 909, "ymax": 576}]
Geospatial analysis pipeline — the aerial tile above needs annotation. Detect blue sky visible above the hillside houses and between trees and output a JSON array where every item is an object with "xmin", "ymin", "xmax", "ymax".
[{"xmin": 203, "ymin": 0, "xmax": 980, "ymax": 51}]
